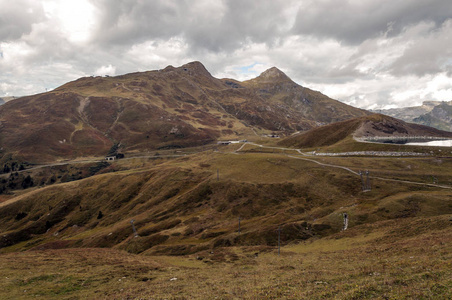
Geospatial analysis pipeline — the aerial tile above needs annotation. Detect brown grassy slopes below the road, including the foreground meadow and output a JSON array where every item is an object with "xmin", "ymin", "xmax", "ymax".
[{"xmin": 0, "ymin": 149, "xmax": 452, "ymax": 299}]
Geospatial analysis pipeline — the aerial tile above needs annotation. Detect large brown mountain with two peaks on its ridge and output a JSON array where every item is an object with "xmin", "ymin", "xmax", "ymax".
[{"xmin": 0, "ymin": 62, "xmax": 368, "ymax": 161}]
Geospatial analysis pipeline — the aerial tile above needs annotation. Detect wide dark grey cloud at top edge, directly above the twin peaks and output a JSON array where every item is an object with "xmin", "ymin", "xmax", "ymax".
[{"xmin": 92, "ymin": 0, "xmax": 290, "ymax": 51}]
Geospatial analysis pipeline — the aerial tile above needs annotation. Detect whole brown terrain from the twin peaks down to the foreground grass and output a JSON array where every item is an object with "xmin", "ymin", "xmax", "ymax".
[{"xmin": 0, "ymin": 62, "xmax": 452, "ymax": 299}]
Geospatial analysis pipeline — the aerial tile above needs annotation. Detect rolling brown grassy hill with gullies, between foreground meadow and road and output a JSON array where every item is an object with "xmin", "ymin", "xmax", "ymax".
[{"xmin": 0, "ymin": 145, "xmax": 452, "ymax": 254}]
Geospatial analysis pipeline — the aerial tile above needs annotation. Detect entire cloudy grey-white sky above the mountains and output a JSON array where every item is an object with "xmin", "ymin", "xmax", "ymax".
[{"xmin": 0, "ymin": 0, "xmax": 452, "ymax": 108}]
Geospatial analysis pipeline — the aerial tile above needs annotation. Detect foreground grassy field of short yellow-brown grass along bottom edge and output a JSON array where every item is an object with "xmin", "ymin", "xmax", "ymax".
[{"xmin": 0, "ymin": 216, "xmax": 452, "ymax": 299}]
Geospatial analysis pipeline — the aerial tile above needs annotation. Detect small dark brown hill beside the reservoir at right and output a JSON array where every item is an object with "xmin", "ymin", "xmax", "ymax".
[{"xmin": 279, "ymin": 114, "xmax": 452, "ymax": 148}]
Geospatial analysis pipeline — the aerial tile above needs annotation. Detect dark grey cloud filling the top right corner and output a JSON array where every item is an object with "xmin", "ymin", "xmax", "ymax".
[{"xmin": 293, "ymin": 0, "xmax": 452, "ymax": 44}]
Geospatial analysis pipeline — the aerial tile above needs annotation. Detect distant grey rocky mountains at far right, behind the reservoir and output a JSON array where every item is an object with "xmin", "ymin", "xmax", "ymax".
[{"xmin": 375, "ymin": 101, "xmax": 452, "ymax": 131}]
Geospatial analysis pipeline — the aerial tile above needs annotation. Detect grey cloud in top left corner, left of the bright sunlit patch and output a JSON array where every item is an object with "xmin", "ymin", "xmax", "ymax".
[{"xmin": 0, "ymin": 0, "xmax": 45, "ymax": 42}]
